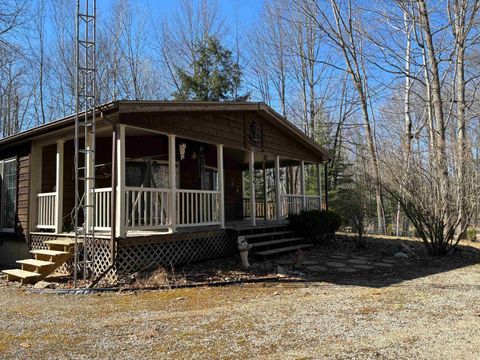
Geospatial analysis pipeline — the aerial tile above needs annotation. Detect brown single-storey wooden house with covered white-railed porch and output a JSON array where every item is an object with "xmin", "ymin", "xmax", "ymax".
[{"xmin": 0, "ymin": 101, "xmax": 329, "ymax": 279}]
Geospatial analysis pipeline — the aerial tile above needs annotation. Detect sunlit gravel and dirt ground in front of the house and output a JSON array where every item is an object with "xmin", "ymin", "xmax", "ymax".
[{"xmin": 0, "ymin": 238, "xmax": 480, "ymax": 360}]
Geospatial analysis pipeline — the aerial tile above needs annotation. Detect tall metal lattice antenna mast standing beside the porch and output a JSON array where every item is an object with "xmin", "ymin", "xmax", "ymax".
[{"xmin": 73, "ymin": 0, "xmax": 97, "ymax": 288}]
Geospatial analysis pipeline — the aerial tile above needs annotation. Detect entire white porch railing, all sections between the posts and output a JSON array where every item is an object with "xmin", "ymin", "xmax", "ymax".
[{"xmin": 37, "ymin": 187, "xmax": 321, "ymax": 231}]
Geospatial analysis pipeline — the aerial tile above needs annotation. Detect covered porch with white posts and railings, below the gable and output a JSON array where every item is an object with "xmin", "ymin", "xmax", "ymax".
[{"xmin": 31, "ymin": 124, "xmax": 324, "ymax": 238}]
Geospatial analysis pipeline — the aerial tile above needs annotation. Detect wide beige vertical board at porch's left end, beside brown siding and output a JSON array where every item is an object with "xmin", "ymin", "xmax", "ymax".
[{"xmin": 29, "ymin": 143, "xmax": 42, "ymax": 231}]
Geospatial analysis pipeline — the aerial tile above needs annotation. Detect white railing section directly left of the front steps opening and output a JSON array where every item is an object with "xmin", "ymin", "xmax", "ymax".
[{"xmin": 176, "ymin": 190, "xmax": 220, "ymax": 227}]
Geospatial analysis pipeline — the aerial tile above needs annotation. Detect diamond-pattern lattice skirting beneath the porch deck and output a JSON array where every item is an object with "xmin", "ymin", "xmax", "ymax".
[{"xmin": 30, "ymin": 230, "xmax": 236, "ymax": 283}]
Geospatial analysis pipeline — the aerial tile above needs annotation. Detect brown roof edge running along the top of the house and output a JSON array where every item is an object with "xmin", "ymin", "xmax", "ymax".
[{"xmin": 0, "ymin": 100, "xmax": 331, "ymax": 160}]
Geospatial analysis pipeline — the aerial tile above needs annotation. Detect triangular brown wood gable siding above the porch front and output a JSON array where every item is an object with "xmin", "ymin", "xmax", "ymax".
[{"xmin": 120, "ymin": 112, "xmax": 322, "ymax": 162}]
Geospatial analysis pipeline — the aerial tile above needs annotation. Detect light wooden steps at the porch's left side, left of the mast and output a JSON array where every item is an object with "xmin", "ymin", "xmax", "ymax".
[{"xmin": 2, "ymin": 239, "xmax": 75, "ymax": 284}]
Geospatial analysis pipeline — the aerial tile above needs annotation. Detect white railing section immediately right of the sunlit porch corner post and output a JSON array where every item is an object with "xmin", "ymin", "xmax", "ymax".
[{"xmin": 125, "ymin": 187, "xmax": 170, "ymax": 230}]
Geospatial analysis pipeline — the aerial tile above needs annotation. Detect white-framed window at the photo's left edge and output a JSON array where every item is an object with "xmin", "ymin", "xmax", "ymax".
[{"xmin": 0, "ymin": 159, "xmax": 17, "ymax": 232}]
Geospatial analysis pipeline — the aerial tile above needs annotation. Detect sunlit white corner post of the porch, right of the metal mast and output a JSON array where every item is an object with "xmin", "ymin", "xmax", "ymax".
[{"xmin": 115, "ymin": 124, "xmax": 126, "ymax": 238}]
